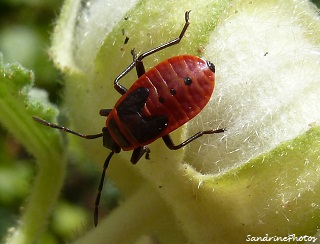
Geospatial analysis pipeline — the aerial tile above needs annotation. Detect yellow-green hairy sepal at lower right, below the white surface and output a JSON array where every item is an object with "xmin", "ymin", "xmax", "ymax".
[{"xmin": 178, "ymin": 127, "xmax": 320, "ymax": 243}]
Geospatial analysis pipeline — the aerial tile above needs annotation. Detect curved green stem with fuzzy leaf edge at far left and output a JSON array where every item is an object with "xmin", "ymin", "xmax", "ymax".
[{"xmin": 0, "ymin": 55, "xmax": 65, "ymax": 243}]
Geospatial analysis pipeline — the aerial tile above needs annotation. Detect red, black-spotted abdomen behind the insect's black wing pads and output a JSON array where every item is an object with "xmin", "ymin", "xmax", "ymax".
[{"xmin": 134, "ymin": 55, "xmax": 215, "ymax": 136}]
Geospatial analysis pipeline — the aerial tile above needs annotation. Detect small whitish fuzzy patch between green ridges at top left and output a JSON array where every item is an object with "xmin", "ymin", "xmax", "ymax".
[{"xmin": 74, "ymin": 0, "xmax": 138, "ymax": 72}]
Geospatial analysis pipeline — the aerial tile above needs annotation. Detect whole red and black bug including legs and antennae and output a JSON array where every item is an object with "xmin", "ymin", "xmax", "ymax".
[{"xmin": 33, "ymin": 11, "xmax": 224, "ymax": 226}]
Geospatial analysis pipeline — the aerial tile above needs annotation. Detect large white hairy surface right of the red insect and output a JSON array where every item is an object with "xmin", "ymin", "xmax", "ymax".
[{"xmin": 186, "ymin": 1, "xmax": 320, "ymax": 173}]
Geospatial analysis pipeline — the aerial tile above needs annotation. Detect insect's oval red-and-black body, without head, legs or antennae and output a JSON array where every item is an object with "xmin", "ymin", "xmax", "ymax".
[{"xmin": 106, "ymin": 55, "xmax": 215, "ymax": 150}]
